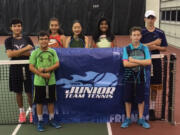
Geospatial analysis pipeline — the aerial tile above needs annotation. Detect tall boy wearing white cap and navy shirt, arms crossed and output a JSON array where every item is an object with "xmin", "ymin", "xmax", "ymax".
[{"xmin": 141, "ymin": 10, "xmax": 168, "ymax": 120}]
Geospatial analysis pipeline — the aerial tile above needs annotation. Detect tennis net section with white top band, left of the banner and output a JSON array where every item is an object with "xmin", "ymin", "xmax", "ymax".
[{"xmin": 0, "ymin": 60, "xmax": 31, "ymax": 124}]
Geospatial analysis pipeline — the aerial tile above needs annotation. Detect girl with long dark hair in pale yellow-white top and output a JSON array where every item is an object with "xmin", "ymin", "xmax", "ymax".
[{"xmin": 92, "ymin": 17, "xmax": 115, "ymax": 48}]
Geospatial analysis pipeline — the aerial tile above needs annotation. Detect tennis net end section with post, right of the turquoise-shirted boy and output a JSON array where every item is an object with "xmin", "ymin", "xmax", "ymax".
[{"xmin": 150, "ymin": 54, "xmax": 176, "ymax": 123}]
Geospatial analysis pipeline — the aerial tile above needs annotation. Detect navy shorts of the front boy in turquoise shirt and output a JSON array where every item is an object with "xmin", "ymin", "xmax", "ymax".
[{"xmin": 124, "ymin": 83, "xmax": 145, "ymax": 104}]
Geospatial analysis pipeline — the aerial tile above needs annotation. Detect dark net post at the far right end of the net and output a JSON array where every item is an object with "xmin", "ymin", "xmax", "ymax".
[{"xmin": 168, "ymin": 54, "xmax": 176, "ymax": 124}]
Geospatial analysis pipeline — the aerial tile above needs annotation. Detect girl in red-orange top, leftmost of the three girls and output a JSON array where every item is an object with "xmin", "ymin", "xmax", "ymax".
[{"xmin": 48, "ymin": 18, "xmax": 66, "ymax": 48}]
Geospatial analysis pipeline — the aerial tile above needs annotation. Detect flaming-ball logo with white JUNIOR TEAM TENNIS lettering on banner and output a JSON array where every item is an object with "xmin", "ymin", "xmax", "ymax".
[{"xmin": 56, "ymin": 71, "xmax": 118, "ymax": 99}]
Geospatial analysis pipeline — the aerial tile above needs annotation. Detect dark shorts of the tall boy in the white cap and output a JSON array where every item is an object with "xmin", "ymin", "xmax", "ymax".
[{"xmin": 151, "ymin": 59, "xmax": 162, "ymax": 84}]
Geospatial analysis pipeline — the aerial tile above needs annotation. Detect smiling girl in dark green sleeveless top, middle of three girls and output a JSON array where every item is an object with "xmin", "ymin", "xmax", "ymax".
[{"xmin": 66, "ymin": 20, "xmax": 88, "ymax": 48}]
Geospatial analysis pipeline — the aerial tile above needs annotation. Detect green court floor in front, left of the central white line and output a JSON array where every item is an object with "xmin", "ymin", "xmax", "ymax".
[{"xmin": 0, "ymin": 123, "xmax": 108, "ymax": 135}]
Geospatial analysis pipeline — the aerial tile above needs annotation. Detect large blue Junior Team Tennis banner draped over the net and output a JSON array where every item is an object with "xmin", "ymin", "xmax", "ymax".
[{"xmin": 34, "ymin": 48, "xmax": 150, "ymax": 123}]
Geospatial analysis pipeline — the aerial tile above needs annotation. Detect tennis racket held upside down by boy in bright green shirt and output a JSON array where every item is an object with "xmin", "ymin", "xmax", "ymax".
[{"xmin": 37, "ymin": 51, "xmax": 54, "ymax": 99}]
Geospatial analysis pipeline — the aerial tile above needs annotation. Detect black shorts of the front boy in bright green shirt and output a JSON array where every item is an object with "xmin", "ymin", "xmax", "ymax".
[{"xmin": 33, "ymin": 85, "xmax": 56, "ymax": 104}]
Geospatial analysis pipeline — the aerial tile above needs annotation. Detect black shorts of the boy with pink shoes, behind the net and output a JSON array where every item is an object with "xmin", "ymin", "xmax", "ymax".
[{"xmin": 9, "ymin": 64, "xmax": 32, "ymax": 93}]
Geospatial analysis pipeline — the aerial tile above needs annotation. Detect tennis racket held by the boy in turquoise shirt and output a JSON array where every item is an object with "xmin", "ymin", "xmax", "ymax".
[{"xmin": 128, "ymin": 49, "xmax": 145, "ymax": 96}]
